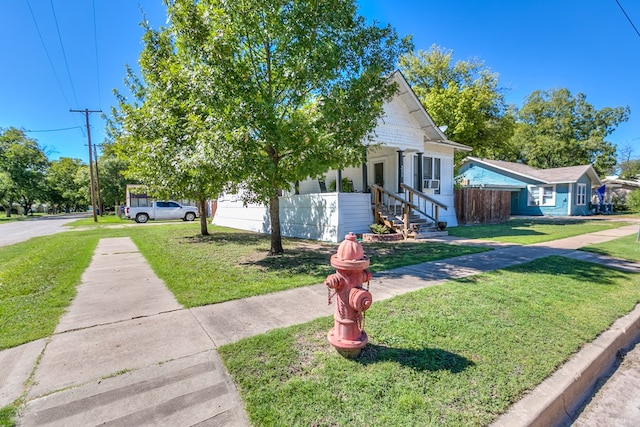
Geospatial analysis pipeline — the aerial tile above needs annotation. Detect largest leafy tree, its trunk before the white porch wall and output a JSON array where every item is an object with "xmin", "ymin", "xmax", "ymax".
[{"xmin": 176, "ymin": 0, "xmax": 408, "ymax": 254}]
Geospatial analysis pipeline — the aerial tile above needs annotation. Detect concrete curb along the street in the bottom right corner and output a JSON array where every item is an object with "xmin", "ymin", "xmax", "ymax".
[{"xmin": 492, "ymin": 304, "xmax": 640, "ymax": 427}]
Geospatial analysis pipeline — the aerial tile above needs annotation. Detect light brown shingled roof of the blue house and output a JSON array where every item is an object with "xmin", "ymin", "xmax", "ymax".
[{"xmin": 463, "ymin": 157, "xmax": 602, "ymax": 186}]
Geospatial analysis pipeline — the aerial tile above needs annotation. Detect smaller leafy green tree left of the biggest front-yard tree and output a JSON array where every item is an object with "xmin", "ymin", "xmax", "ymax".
[{"xmin": 108, "ymin": 3, "xmax": 239, "ymax": 235}]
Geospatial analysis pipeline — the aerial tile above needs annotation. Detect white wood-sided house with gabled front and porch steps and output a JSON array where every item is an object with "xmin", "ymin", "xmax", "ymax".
[{"xmin": 213, "ymin": 71, "xmax": 471, "ymax": 242}]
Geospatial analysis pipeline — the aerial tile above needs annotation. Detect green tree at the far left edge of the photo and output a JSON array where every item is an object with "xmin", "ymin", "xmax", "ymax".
[{"xmin": 0, "ymin": 127, "xmax": 49, "ymax": 216}]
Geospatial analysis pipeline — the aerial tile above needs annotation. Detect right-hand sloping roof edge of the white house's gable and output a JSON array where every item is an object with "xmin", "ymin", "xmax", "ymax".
[{"xmin": 389, "ymin": 70, "xmax": 473, "ymax": 151}]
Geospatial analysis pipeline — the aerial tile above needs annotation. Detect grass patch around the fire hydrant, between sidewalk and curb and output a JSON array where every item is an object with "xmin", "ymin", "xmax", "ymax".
[{"xmin": 219, "ymin": 257, "xmax": 640, "ymax": 426}]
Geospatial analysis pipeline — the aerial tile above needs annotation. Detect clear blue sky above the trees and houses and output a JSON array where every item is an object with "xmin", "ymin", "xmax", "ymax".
[{"xmin": 0, "ymin": 0, "xmax": 640, "ymax": 165}]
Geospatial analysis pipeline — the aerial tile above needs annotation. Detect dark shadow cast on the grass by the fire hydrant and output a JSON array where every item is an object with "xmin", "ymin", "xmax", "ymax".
[{"xmin": 356, "ymin": 344, "xmax": 475, "ymax": 374}]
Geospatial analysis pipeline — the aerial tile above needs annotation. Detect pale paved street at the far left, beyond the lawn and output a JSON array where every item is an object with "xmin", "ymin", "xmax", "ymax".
[{"xmin": 0, "ymin": 212, "xmax": 90, "ymax": 246}]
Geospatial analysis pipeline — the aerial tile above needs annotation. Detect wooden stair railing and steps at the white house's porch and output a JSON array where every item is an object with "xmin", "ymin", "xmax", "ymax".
[{"xmin": 371, "ymin": 184, "xmax": 447, "ymax": 239}]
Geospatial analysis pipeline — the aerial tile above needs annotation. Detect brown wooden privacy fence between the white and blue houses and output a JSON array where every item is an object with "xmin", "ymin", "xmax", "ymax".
[{"xmin": 454, "ymin": 188, "xmax": 511, "ymax": 225}]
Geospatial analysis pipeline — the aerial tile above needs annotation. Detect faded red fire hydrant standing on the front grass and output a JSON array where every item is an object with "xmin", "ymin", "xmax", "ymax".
[{"xmin": 324, "ymin": 233, "xmax": 373, "ymax": 358}]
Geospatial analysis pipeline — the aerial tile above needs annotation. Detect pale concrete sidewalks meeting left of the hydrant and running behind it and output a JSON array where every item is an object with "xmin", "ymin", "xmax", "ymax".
[{"xmin": 0, "ymin": 225, "xmax": 640, "ymax": 426}]
